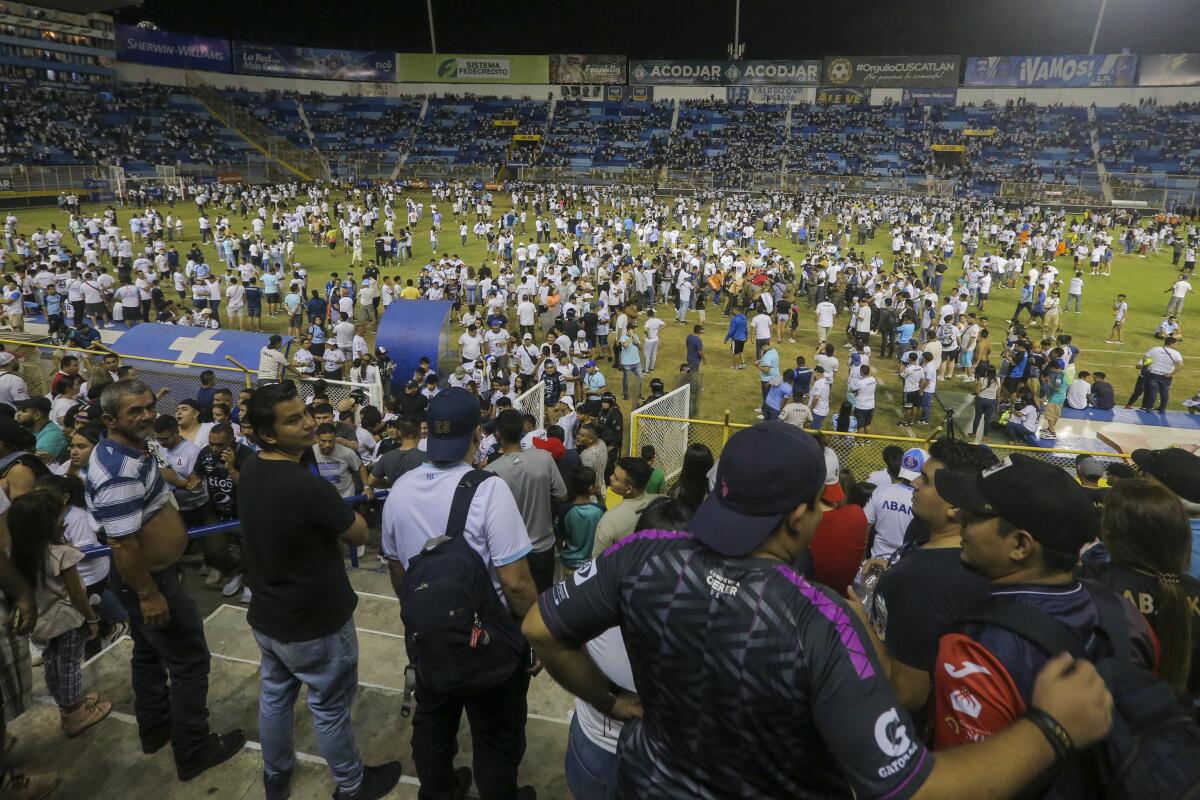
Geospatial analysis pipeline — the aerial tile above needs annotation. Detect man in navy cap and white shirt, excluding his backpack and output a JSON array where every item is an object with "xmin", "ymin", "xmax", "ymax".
[{"xmin": 382, "ymin": 387, "xmax": 538, "ymax": 800}]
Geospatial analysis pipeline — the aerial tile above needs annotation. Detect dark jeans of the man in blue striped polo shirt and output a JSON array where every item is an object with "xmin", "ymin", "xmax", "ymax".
[{"xmin": 109, "ymin": 564, "xmax": 210, "ymax": 765}]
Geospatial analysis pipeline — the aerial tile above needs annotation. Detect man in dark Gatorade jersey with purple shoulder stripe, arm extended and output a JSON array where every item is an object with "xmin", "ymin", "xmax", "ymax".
[{"xmin": 523, "ymin": 422, "xmax": 1111, "ymax": 800}]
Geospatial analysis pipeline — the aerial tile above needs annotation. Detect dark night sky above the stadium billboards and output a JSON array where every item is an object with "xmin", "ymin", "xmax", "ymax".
[{"xmin": 118, "ymin": 0, "xmax": 1200, "ymax": 59}]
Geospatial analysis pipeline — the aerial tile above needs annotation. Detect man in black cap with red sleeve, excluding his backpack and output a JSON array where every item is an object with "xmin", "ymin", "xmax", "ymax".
[{"xmin": 934, "ymin": 453, "xmax": 1156, "ymax": 762}]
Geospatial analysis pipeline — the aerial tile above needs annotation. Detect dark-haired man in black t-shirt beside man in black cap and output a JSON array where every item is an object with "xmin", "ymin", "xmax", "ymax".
[{"xmin": 851, "ymin": 439, "xmax": 996, "ymax": 714}]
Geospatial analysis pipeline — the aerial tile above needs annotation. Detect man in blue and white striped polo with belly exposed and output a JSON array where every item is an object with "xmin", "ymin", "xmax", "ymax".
[{"xmin": 84, "ymin": 379, "xmax": 246, "ymax": 781}]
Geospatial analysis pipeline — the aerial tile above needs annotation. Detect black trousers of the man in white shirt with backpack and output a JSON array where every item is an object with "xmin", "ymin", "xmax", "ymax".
[{"xmin": 413, "ymin": 669, "xmax": 529, "ymax": 800}]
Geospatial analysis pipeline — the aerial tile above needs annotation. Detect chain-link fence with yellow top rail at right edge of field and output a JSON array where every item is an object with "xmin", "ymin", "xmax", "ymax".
[{"xmin": 630, "ymin": 407, "xmax": 1128, "ymax": 489}]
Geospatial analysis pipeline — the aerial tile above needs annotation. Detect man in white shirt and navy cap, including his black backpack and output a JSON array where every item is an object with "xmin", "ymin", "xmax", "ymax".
[{"xmin": 382, "ymin": 387, "xmax": 536, "ymax": 800}]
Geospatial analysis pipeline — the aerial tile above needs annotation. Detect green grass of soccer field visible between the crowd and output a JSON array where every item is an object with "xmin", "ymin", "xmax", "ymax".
[{"xmin": 16, "ymin": 192, "xmax": 1200, "ymax": 441}]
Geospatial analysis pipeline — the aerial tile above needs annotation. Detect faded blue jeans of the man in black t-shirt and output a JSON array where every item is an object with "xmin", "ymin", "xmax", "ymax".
[{"xmin": 252, "ymin": 616, "xmax": 362, "ymax": 794}]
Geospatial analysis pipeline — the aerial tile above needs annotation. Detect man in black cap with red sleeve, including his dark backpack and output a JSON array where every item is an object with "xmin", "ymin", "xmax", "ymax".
[{"xmin": 934, "ymin": 453, "xmax": 1200, "ymax": 798}]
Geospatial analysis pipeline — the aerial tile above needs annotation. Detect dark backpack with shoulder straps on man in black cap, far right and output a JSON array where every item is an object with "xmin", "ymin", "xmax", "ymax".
[{"xmin": 959, "ymin": 581, "xmax": 1200, "ymax": 800}]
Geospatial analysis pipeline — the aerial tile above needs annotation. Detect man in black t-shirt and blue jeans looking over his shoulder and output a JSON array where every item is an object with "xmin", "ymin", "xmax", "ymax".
[{"xmin": 238, "ymin": 381, "xmax": 400, "ymax": 800}]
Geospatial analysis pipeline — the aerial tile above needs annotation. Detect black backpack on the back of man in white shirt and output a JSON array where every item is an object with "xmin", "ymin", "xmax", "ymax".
[{"xmin": 400, "ymin": 469, "xmax": 529, "ymax": 697}]
